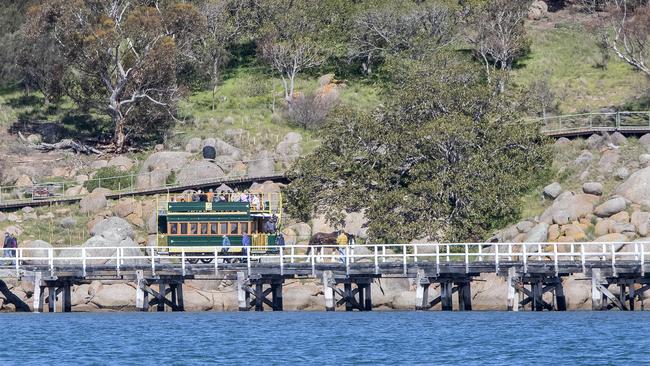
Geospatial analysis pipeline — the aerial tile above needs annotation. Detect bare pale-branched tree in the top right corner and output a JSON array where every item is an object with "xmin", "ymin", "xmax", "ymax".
[{"xmin": 599, "ymin": 0, "xmax": 650, "ymax": 77}]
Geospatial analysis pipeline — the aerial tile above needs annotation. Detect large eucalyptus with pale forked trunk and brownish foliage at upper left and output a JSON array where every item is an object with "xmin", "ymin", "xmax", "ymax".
[{"xmin": 24, "ymin": 0, "xmax": 204, "ymax": 151}]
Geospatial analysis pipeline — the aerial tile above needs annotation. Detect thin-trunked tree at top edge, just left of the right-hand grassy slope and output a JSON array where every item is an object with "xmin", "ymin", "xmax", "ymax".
[{"xmin": 467, "ymin": 0, "xmax": 531, "ymax": 92}]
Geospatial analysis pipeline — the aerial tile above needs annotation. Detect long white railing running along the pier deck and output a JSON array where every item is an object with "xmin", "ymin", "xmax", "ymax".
[{"xmin": 0, "ymin": 242, "xmax": 650, "ymax": 275}]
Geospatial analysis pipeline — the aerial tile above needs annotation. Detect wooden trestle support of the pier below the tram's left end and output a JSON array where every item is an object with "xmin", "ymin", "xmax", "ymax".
[{"xmin": 135, "ymin": 271, "xmax": 185, "ymax": 311}]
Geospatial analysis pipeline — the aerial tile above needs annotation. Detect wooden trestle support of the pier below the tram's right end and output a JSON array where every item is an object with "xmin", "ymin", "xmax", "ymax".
[{"xmin": 237, "ymin": 272, "xmax": 284, "ymax": 311}]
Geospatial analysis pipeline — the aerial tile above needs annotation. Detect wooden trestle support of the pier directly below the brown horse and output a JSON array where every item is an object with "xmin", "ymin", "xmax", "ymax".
[{"xmin": 323, "ymin": 271, "xmax": 375, "ymax": 311}]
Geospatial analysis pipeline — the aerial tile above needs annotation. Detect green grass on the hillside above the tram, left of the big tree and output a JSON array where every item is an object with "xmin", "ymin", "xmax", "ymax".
[{"xmin": 173, "ymin": 68, "xmax": 380, "ymax": 153}]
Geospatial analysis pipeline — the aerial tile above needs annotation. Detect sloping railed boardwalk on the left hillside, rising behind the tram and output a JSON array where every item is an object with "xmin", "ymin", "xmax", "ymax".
[{"xmin": 0, "ymin": 157, "xmax": 295, "ymax": 206}]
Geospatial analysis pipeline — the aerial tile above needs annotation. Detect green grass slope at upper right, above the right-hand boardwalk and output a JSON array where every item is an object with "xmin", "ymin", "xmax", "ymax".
[{"xmin": 514, "ymin": 23, "xmax": 647, "ymax": 113}]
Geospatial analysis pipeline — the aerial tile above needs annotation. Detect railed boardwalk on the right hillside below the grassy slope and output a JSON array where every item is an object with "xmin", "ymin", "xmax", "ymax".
[{"xmin": 531, "ymin": 111, "xmax": 650, "ymax": 136}]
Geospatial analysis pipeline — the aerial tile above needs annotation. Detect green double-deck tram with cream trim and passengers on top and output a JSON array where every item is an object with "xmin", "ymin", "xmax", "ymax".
[{"xmin": 157, "ymin": 193, "xmax": 282, "ymax": 263}]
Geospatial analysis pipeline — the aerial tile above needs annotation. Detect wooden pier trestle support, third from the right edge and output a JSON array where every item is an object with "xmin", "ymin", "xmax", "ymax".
[{"xmin": 415, "ymin": 269, "xmax": 473, "ymax": 311}]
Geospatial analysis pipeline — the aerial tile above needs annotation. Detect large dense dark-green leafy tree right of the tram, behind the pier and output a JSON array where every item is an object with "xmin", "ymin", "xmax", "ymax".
[{"xmin": 289, "ymin": 54, "xmax": 550, "ymax": 242}]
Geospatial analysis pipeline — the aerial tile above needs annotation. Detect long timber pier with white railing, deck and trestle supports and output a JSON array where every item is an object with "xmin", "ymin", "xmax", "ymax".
[{"xmin": 0, "ymin": 243, "xmax": 650, "ymax": 312}]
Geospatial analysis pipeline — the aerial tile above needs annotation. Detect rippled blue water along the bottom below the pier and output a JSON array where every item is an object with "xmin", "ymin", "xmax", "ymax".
[{"xmin": 0, "ymin": 311, "xmax": 650, "ymax": 366}]
